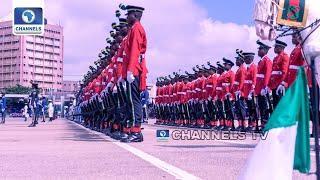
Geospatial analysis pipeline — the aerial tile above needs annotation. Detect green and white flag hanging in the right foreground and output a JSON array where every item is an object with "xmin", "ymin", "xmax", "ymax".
[{"xmin": 239, "ymin": 68, "xmax": 310, "ymax": 180}]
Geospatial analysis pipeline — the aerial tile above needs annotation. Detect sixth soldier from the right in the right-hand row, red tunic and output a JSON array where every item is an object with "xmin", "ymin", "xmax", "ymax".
[{"xmin": 222, "ymin": 58, "xmax": 235, "ymax": 130}]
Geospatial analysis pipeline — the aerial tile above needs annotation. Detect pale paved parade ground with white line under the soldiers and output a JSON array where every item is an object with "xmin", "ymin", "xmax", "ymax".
[{"xmin": 0, "ymin": 118, "xmax": 315, "ymax": 180}]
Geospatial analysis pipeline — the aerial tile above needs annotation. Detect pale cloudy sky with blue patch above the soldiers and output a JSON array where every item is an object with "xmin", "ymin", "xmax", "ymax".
[{"xmin": 0, "ymin": 0, "xmax": 291, "ymax": 83}]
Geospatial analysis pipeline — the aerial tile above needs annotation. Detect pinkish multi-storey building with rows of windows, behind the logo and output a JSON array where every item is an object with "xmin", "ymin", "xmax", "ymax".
[{"xmin": 0, "ymin": 17, "xmax": 64, "ymax": 92}]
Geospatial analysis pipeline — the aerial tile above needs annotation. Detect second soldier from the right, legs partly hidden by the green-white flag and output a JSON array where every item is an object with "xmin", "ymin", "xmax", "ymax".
[{"xmin": 268, "ymin": 40, "xmax": 289, "ymax": 108}]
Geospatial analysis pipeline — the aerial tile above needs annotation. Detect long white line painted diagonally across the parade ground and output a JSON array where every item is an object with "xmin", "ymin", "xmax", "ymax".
[{"xmin": 70, "ymin": 121, "xmax": 200, "ymax": 180}]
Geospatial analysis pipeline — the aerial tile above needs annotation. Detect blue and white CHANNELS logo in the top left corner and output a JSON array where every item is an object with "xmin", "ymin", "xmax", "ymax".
[{"xmin": 12, "ymin": 0, "xmax": 44, "ymax": 35}]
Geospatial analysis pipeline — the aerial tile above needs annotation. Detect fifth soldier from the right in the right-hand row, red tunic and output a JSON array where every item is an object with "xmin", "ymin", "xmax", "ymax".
[{"xmin": 232, "ymin": 50, "xmax": 246, "ymax": 131}]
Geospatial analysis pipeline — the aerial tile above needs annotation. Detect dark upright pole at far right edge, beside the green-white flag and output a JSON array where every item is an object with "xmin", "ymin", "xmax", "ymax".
[{"xmin": 310, "ymin": 58, "xmax": 320, "ymax": 180}]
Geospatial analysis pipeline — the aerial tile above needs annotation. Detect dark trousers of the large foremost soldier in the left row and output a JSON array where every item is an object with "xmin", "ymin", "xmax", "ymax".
[{"xmin": 127, "ymin": 77, "xmax": 142, "ymax": 127}]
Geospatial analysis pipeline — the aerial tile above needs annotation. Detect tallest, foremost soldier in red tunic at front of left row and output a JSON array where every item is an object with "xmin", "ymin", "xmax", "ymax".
[{"xmin": 121, "ymin": 6, "xmax": 147, "ymax": 142}]
